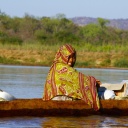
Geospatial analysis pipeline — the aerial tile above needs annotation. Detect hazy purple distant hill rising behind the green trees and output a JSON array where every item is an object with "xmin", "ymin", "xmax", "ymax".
[{"xmin": 70, "ymin": 17, "xmax": 128, "ymax": 30}]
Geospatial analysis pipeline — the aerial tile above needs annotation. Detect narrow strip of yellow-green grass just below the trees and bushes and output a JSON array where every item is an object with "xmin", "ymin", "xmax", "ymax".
[{"xmin": 0, "ymin": 43, "xmax": 128, "ymax": 53}]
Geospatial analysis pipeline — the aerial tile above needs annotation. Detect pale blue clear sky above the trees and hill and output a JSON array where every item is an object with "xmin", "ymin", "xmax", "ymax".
[{"xmin": 0, "ymin": 0, "xmax": 128, "ymax": 19}]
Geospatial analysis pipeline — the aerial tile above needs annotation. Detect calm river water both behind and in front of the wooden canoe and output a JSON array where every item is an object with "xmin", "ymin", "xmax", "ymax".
[{"xmin": 0, "ymin": 65, "xmax": 128, "ymax": 128}]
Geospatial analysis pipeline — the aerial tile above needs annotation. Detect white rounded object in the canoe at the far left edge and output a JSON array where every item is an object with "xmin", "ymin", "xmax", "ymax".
[{"xmin": 0, "ymin": 89, "xmax": 16, "ymax": 101}]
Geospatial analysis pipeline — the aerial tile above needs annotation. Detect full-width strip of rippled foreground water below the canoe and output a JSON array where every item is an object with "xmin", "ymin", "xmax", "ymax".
[{"xmin": 0, "ymin": 115, "xmax": 128, "ymax": 128}]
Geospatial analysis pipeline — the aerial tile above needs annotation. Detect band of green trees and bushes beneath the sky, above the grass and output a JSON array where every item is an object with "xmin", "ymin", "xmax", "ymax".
[{"xmin": 0, "ymin": 11, "xmax": 128, "ymax": 45}]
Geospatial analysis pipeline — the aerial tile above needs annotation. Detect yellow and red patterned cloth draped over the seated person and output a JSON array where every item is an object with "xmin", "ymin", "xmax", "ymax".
[{"xmin": 43, "ymin": 44, "xmax": 99, "ymax": 110}]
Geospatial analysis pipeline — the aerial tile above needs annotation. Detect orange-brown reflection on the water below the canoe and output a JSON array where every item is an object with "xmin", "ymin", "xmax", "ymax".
[{"xmin": 42, "ymin": 116, "xmax": 100, "ymax": 128}]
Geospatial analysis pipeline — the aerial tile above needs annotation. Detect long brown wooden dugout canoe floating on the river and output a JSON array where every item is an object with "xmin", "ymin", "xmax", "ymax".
[{"xmin": 0, "ymin": 99, "xmax": 128, "ymax": 117}]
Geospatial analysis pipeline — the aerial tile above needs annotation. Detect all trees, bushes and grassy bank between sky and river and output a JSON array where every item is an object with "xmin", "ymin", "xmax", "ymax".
[{"xmin": 0, "ymin": 12, "xmax": 128, "ymax": 68}]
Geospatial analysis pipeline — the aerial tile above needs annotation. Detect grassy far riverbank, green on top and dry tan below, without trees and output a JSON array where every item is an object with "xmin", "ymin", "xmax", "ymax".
[{"xmin": 0, "ymin": 43, "xmax": 128, "ymax": 68}]
